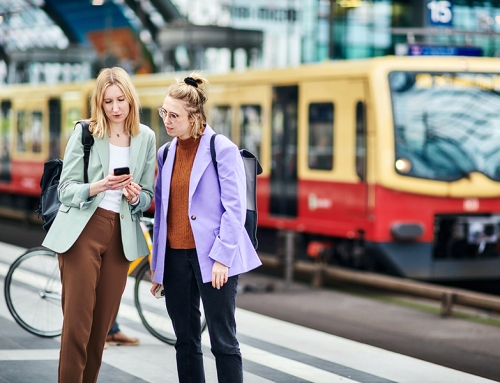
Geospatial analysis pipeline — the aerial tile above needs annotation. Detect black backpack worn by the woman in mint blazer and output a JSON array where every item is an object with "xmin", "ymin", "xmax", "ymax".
[{"xmin": 36, "ymin": 121, "xmax": 94, "ymax": 231}]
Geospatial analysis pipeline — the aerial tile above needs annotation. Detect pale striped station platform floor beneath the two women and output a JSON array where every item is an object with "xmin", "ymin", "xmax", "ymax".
[{"xmin": 0, "ymin": 244, "xmax": 500, "ymax": 383}]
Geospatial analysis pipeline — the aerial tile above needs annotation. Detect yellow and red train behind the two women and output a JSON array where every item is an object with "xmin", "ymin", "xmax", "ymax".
[{"xmin": 0, "ymin": 57, "xmax": 500, "ymax": 280}]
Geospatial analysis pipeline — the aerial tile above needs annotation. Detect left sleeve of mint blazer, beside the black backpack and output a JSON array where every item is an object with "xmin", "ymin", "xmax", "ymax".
[{"xmin": 58, "ymin": 124, "xmax": 96, "ymax": 210}]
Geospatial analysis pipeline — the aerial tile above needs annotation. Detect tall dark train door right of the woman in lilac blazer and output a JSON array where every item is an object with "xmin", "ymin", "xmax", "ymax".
[{"xmin": 269, "ymin": 86, "xmax": 298, "ymax": 217}]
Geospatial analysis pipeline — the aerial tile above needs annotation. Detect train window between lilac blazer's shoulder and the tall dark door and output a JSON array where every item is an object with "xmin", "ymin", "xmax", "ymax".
[{"xmin": 240, "ymin": 105, "xmax": 262, "ymax": 157}]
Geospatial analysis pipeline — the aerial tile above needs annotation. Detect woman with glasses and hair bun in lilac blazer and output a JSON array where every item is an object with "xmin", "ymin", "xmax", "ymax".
[{"xmin": 151, "ymin": 73, "xmax": 261, "ymax": 383}]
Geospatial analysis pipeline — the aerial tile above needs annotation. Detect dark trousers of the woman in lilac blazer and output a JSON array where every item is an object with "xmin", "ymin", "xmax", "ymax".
[{"xmin": 163, "ymin": 248, "xmax": 243, "ymax": 383}]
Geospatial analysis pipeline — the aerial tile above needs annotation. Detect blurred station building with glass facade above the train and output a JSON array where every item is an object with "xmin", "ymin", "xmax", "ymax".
[{"xmin": 0, "ymin": 0, "xmax": 500, "ymax": 84}]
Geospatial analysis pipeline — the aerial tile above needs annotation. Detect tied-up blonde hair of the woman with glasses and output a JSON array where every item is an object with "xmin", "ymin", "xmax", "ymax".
[{"xmin": 167, "ymin": 72, "xmax": 208, "ymax": 138}]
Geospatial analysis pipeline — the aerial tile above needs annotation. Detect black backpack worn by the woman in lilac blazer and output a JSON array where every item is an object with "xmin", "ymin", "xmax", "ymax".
[{"xmin": 163, "ymin": 133, "xmax": 262, "ymax": 249}]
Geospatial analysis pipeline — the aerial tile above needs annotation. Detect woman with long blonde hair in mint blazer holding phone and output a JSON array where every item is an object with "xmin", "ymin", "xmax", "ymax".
[{"xmin": 43, "ymin": 67, "xmax": 156, "ymax": 383}]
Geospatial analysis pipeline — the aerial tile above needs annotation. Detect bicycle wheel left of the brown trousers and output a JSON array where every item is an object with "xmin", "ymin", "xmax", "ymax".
[{"xmin": 4, "ymin": 247, "xmax": 63, "ymax": 338}]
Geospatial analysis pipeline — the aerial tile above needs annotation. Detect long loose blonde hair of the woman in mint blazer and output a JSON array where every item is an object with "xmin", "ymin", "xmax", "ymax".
[{"xmin": 89, "ymin": 67, "xmax": 140, "ymax": 138}]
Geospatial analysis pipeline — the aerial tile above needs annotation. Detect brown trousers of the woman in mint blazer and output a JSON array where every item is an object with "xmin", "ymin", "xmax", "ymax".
[{"xmin": 59, "ymin": 208, "xmax": 129, "ymax": 383}]
